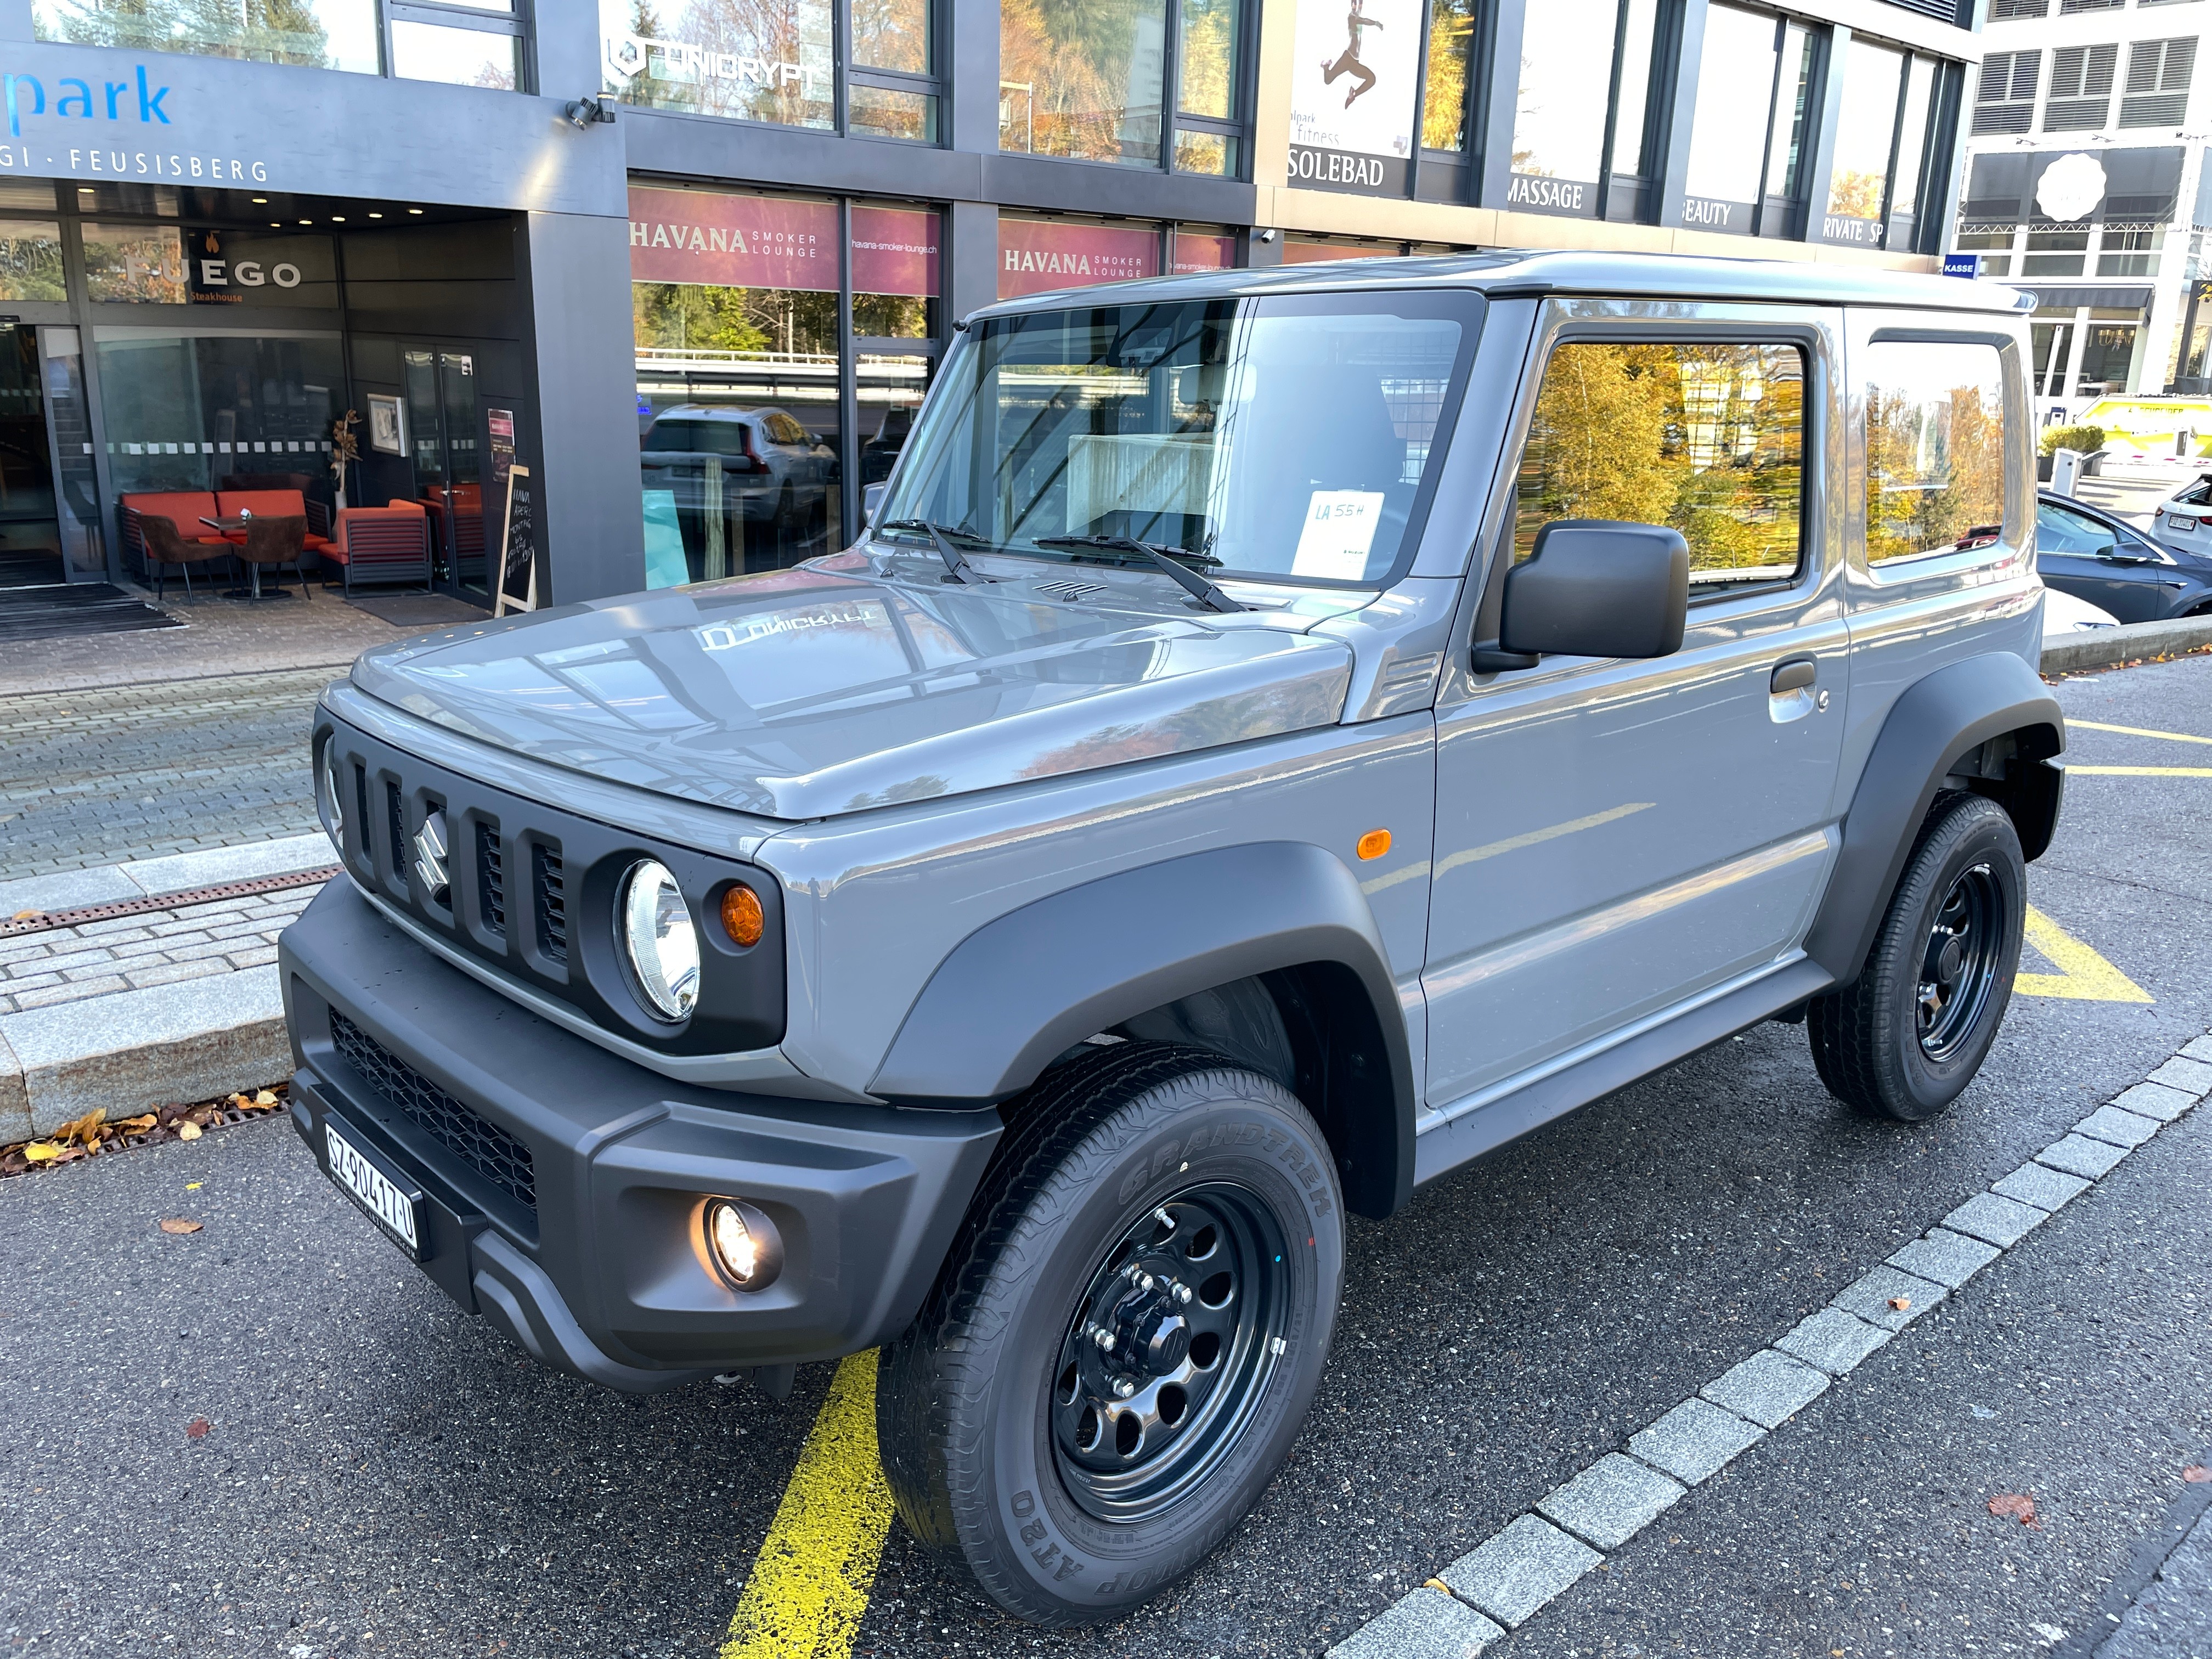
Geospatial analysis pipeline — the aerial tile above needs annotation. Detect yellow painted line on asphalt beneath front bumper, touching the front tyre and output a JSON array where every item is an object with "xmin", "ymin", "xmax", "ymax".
[{"xmin": 719, "ymin": 1350, "xmax": 891, "ymax": 1659}]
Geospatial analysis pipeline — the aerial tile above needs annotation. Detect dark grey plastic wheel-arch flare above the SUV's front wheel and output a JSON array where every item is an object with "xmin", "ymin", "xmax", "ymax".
[{"xmin": 870, "ymin": 840, "xmax": 1415, "ymax": 1212}]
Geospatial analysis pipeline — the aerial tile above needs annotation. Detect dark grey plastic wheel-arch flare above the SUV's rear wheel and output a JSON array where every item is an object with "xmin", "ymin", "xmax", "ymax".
[{"xmin": 1805, "ymin": 652, "xmax": 2066, "ymax": 986}]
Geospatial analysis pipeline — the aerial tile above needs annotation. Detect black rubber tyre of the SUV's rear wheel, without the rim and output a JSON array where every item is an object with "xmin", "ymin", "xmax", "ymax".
[{"xmin": 1805, "ymin": 794, "xmax": 2026, "ymax": 1124}]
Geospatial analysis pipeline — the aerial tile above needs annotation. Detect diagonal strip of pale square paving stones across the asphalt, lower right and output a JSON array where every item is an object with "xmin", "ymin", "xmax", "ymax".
[{"xmin": 1329, "ymin": 1057, "xmax": 2212, "ymax": 1659}]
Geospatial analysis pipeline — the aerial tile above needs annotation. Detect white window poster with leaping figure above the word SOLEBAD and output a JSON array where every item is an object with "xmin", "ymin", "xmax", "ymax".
[{"xmin": 1290, "ymin": 0, "xmax": 1420, "ymax": 197}]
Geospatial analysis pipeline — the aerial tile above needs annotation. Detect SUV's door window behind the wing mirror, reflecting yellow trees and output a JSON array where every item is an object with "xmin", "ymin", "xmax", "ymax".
[{"xmin": 1513, "ymin": 341, "xmax": 1805, "ymax": 602}]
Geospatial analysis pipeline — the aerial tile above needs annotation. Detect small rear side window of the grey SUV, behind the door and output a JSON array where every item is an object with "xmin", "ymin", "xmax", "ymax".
[{"xmin": 1865, "ymin": 341, "xmax": 2004, "ymax": 564}]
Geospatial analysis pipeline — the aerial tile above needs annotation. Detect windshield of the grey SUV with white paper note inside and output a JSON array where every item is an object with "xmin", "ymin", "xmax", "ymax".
[{"xmin": 874, "ymin": 292, "xmax": 1482, "ymax": 584}]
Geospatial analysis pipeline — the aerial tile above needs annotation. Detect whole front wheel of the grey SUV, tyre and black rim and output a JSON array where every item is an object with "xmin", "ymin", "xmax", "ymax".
[{"xmin": 876, "ymin": 1042, "xmax": 1345, "ymax": 1626}]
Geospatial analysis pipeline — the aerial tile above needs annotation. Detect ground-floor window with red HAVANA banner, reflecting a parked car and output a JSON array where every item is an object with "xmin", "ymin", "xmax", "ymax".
[{"xmin": 630, "ymin": 186, "xmax": 940, "ymax": 586}]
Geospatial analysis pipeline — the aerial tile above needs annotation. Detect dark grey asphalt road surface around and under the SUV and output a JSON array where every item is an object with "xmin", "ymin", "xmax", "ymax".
[{"xmin": 0, "ymin": 659, "xmax": 2212, "ymax": 1659}]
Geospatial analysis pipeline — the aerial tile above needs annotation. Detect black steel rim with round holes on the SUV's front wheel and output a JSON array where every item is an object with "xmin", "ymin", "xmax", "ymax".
[{"xmin": 1053, "ymin": 1183, "xmax": 1285, "ymax": 1522}]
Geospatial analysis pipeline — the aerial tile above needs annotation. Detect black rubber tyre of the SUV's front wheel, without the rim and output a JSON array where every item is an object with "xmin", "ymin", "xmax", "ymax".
[{"xmin": 876, "ymin": 1042, "xmax": 1342, "ymax": 1626}]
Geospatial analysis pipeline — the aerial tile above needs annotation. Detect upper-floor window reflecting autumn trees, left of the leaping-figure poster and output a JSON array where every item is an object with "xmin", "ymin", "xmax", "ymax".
[{"xmin": 997, "ymin": 0, "xmax": 1245, "ymax": 177}]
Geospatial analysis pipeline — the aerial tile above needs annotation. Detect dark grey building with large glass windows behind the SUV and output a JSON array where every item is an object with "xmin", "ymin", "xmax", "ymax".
[{"xmin": 0, "ymin": 0, "xmax": 1982, "ymax": 602}]
